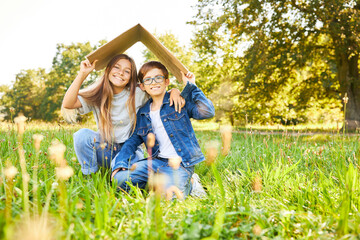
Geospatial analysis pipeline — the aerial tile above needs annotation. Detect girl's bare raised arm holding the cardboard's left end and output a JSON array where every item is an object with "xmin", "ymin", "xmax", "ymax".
[{"xmin": 62, "ymin": 59, "xmax": 97, "ymax": 109}]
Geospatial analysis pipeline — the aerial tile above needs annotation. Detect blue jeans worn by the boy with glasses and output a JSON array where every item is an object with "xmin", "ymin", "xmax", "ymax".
[{"xmin": 113, "ymin": 158, "xmax": 194, "ymax": 196}]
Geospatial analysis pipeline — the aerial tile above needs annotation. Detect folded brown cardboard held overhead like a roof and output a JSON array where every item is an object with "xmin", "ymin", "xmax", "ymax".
[{"xmin": 86, "ymin": 24, "xmax": 188, "ymax": 83}]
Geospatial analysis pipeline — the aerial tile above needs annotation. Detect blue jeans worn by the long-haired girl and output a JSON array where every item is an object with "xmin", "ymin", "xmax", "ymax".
[{"xmin": 74, "ymin": 128, "xmax": 144, "ymax": 175}]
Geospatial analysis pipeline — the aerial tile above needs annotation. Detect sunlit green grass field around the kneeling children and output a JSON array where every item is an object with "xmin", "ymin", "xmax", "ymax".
[{"xmin": 0, "ymin": 121, "xmax": 360, "ymax": 239}]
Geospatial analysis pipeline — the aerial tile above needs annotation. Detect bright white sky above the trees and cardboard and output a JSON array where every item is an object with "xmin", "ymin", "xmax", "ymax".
[{"xmin": 0, "ymin": 0, "xmax": 196, "ymax": 85}]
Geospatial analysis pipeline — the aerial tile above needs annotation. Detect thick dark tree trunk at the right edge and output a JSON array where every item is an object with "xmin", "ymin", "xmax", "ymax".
[{"xmin": 337, "ymin": 52, "xmax": 360, "ymax": 131}]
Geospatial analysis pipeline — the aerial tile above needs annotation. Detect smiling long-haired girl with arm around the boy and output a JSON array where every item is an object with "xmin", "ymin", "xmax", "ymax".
[{"xmin": 62, "ymin": 54, "xmax": 183, "ymax": 175}]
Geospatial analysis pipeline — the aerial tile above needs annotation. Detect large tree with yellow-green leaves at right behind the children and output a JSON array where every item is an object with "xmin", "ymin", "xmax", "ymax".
[{"xmin": 192, "ymin": 0, "xmax": 360, "ymax": 128}]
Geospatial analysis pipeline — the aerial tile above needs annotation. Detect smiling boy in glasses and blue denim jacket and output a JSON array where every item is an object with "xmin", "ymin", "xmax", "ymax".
[{"xmin": 111, "ymin": 61, "xmax": 215, "ymax": 196}]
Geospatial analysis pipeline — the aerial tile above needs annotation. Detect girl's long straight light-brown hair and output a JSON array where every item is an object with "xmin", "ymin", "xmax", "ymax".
[{"xmin": 79, "ymin": 54, "xmax": 137, "ymax": 143}]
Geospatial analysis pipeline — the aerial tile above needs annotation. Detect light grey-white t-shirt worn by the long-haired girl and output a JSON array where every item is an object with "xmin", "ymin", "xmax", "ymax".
[{"xmin": 77, "ymin": 87, "xmax": 148, "ymax": 143}]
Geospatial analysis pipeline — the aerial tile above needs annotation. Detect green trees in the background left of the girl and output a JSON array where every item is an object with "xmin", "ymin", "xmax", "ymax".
[{"xmin": 0, "ymin": 41, "xmax": 105, "ymax": 121}]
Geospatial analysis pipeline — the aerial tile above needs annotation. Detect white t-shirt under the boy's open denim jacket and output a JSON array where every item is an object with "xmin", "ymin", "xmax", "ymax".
[{"xmin": 150, "ymin": 109, "xmax": 178, "ymax": 158}]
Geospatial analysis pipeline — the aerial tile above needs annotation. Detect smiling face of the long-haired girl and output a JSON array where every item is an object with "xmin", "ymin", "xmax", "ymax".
[{"xmin": 109, "ymin": 59, "xmax": 131, "ymax": 94}]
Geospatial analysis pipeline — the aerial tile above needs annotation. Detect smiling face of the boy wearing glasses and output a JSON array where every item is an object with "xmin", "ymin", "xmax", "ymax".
[{"xmin": 140, "ymin": 68, "xmax": 170, "ymax": 97}]
